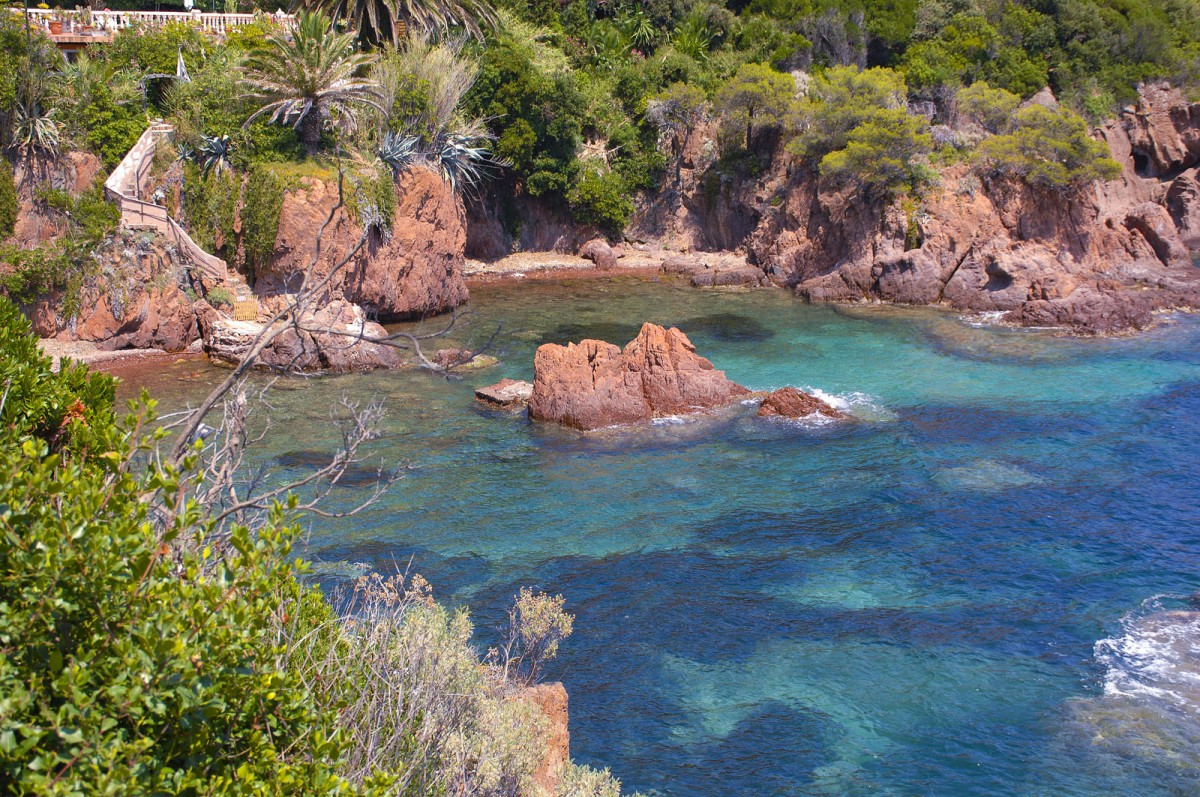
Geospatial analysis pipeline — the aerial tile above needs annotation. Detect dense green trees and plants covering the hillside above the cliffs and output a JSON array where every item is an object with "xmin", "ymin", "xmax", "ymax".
[{"xmin": 0, "ymin": 0, "xmax": 1180, "ymax": 250}]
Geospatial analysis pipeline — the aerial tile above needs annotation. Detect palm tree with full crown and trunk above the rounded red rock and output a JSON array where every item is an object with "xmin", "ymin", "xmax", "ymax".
[{"xmin": 246, "ymin": 11, "xmax": 382, "ymax": 154}]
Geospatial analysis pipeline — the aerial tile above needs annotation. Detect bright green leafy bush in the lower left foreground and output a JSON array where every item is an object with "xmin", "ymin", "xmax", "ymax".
[{"xmin": 0, "ymin": 300, "xmax": 355, "ymax": 795}]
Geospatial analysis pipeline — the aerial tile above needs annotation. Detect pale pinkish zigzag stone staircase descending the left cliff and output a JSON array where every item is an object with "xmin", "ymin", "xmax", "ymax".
[{"xmin": 104, "ymin": 121, "xmax": 229, "ymax": 284}]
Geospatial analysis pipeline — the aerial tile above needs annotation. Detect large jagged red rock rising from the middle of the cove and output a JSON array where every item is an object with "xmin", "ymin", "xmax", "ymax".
[{"xmin": 529, "ymin": 324, "xmax": 750, "ymax": 430}]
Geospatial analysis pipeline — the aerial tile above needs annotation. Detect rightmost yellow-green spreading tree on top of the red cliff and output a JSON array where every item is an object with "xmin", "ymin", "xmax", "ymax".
[{"xmin": 977, "ymin": 106, "xmax": 1121, "ymax": 190}]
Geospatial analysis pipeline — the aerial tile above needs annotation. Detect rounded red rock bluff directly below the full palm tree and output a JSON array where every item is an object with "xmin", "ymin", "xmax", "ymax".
[{"xmin": 254, "ymin": 168, "xmax": 467, "ymax": 319}]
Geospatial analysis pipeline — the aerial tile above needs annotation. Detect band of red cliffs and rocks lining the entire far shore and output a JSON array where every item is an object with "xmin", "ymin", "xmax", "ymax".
[{"xmin": 18, "ymin": 84, "xmax": 1200, "ymax": 360}]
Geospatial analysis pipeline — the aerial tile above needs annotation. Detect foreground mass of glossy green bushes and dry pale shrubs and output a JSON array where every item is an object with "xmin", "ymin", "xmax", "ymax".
[{"xmin": 0, "ymin": 298, "xmax": 638, "ymax": 797}]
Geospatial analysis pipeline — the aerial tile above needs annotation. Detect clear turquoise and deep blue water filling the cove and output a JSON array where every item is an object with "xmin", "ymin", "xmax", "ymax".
[{"xmin": 119, "ymin": 280, "xmax": 1200, "ymax": 797}]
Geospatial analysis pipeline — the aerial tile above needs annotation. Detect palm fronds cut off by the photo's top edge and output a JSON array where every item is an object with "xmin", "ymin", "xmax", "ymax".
[{"xmin": 299, "ymin": 0, "xmax": 498, "ymax": 47}]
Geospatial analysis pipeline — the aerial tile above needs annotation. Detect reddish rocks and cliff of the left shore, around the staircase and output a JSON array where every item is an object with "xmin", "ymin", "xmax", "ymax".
[{"xmin": 13, "ymin": 166, "xmax": 467, "ymax": 371}]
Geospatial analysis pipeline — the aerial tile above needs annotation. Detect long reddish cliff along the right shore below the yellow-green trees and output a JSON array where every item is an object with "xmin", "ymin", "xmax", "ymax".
[{"xmin": 631, "ymin": 78, "xmax": 1200, "ymax": 334}]
